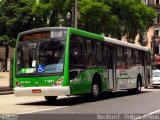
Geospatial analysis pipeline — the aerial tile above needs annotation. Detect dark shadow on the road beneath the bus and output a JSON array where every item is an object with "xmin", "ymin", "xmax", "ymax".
[{"xmin": 17, "ymin": 91, "xmax": 149, "ymax": 106}]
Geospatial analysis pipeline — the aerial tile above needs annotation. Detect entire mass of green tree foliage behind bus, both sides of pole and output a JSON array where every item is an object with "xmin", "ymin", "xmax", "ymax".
[{"xmin": 0, "ymin": 0, "xmax": 156, "ymax": 45}]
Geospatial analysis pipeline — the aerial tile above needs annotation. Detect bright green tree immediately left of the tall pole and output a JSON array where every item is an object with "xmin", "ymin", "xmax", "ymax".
[{"xmin": 32, "ymin": 0, "xmax": 66, "ymax": 27}]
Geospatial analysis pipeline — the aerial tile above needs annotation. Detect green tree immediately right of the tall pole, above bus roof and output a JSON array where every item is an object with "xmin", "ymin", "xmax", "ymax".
[{"xmin": 79, "ymin": 0, "xmax": 118, "ymax": 34}]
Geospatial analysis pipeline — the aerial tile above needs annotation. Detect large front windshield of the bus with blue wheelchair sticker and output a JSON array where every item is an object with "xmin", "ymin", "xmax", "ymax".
[{"xmin": 16, "ymin": 38, "xmax": 65, "ymax": 75}]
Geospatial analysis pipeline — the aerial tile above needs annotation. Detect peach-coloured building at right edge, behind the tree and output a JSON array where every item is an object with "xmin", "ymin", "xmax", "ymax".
[{"xmin": 142, "ymin": 0, "xmax": 160, "ymax": 69}]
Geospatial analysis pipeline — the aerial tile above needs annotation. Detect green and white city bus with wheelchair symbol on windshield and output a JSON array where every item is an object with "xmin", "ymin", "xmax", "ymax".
[{"xmin": 13, "ymin": 27, "xmax": 151, "ymax": 101}]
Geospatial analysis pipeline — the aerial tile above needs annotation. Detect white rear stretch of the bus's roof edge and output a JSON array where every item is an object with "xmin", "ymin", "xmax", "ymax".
[{"xmin": 104, "ymin": 37, "xmax": 149, "ymax": 51}]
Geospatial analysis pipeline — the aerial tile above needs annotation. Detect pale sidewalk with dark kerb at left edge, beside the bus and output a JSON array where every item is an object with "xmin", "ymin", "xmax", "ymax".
[{"xmin": 0, "ymin": 72, "xmax": 13, "ymax": 95}]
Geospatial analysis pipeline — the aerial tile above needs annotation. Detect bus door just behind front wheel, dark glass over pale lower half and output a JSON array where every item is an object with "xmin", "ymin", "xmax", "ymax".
[{"xmin": 107, "ymin": 46, "xmax": 115, "ymax": 89}]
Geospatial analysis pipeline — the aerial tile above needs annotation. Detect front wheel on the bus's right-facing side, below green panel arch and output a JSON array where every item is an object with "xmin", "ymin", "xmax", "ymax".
[{"xmin": 91, "ymin": 80, "xmax": 101, "ymax": 101}]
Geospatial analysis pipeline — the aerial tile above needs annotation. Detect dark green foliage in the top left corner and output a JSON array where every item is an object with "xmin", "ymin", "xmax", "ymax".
[{"xmin": 0, "ymin": 0, "xmax": 36, "ymax": 46}]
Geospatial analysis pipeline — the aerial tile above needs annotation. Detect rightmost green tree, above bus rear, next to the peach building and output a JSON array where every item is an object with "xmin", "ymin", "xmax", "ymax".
[{"xmin": 105, "ymin": 0, "xmax": 156, "ymax": 41}]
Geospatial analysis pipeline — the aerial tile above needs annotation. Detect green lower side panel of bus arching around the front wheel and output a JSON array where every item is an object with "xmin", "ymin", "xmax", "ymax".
[{"xmin": 70, "ymin": 67, "xmax": 107, "ymax": 95}]
